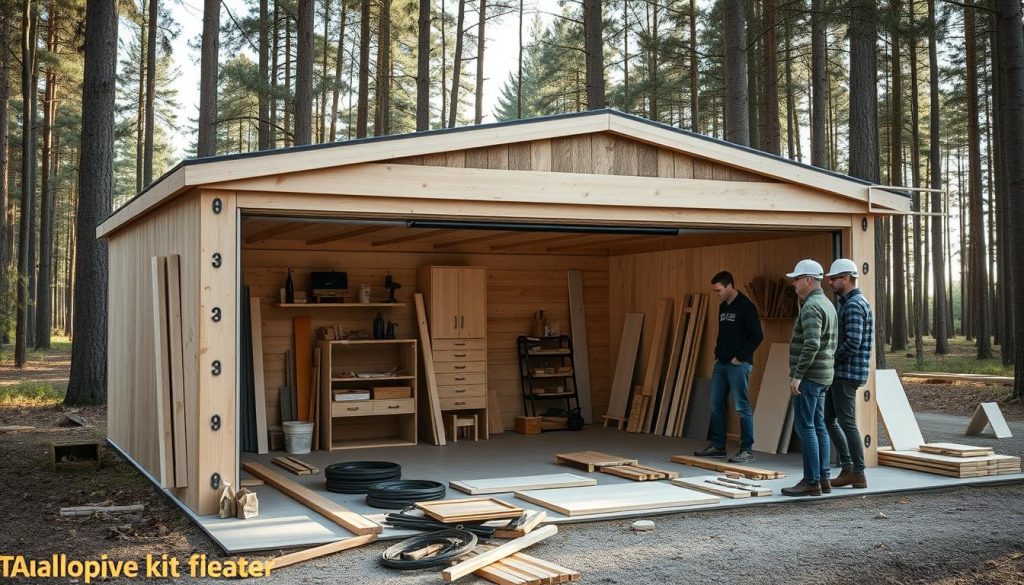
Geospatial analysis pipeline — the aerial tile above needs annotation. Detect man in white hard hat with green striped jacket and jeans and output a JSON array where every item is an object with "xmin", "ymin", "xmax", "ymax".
[{"xmin": 782, "ymin": 259, "xmax": 837, "ymax": 496}]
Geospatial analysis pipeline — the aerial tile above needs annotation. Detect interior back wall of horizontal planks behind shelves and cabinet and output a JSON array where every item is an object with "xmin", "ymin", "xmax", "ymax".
[{"xmin": 242, "ymin": 243, "xmax": 610, "ymax": 428}]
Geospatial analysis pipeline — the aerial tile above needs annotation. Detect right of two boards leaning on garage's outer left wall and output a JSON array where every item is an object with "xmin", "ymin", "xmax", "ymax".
[{"xmin": 167, "ymin": 254, "xmax": 188, "ymax": 488}]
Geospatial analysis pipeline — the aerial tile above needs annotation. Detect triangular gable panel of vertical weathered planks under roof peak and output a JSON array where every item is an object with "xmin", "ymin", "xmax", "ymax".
[{"xmin": 391, "ymin": 132, "xmax": 774, "ymax": 182}]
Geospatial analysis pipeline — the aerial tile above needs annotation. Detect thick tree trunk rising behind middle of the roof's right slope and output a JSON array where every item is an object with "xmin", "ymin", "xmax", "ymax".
[{"xmin": 723, "ymin": 0, "xmax": 751, "ymax": 145}]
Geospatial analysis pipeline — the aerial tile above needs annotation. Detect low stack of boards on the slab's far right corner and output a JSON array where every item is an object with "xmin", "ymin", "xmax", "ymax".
[{"xmin": 879, "ymin": 444, "xmax": 1021, "ymax": 477}]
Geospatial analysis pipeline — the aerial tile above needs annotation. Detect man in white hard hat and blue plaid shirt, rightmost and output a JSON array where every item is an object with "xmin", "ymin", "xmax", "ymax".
[{"xmin": 825, "ymin": 258, "xmax": 874, "ymax": 488}]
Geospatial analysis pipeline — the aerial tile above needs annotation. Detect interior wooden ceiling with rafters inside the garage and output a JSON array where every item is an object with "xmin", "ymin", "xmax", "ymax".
[{"xmin": 242, "ymin": 216, "xmax": 808, "ymax": 256}]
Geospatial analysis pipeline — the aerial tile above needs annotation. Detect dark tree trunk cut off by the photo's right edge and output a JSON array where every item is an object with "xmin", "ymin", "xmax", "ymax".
[{"xmin": 993, "ymin": 0, "xmax": 1024, "ymax": 400}]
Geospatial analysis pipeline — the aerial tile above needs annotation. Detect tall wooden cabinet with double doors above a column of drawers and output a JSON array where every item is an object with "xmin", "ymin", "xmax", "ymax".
[{"xmin": 420, "ymin": 266, "xmax": 489, "ymax": 438}]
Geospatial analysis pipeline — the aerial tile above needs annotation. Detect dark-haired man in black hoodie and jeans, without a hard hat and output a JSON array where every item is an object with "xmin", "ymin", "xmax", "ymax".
[{"xmin": 695, "ymin": 271, "xmax": 765, "ymax": 463}]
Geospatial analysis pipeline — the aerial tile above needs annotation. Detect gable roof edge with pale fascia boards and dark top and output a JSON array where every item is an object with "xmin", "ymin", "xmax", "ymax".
[{"xmin": 97, "ymin": 109, "xmax": 909, "ymax": 237}]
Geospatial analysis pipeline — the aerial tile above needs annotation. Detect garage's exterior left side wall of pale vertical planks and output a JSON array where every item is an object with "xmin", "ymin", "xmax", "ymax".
[{"xmin": 106, "ymin": 194, "xmax": 200, "ymax": 499}]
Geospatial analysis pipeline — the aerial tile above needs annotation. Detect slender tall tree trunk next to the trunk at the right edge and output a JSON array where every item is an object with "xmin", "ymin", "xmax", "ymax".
[{"xmin": 964, "ymin": 0, "xmax": 992, "ymax": 360}]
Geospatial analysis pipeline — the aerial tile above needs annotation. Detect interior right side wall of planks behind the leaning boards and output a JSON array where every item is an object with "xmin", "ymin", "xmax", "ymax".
[{"xmin": 608, "ymin": 234, "xmax": 833, "ymax": 432}]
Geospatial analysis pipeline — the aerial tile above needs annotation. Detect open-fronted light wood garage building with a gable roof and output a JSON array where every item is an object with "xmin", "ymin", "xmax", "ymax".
[{"xmin": 97, "ymin": 110, "xmax": 909, "ymax": 514}]
